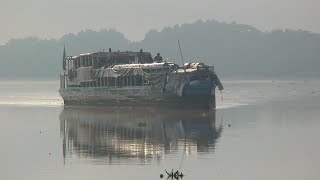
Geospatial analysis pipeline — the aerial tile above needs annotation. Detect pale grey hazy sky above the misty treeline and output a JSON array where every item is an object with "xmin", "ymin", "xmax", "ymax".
[{"xmin": 0, "ymin": 0, "xmax": 320, "ymax": 44}]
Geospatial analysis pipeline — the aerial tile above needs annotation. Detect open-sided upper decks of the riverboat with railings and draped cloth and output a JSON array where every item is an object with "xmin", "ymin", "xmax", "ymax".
[{"xmin": 61, "ymin": 50, "xmax": 179, "ymax": 88}]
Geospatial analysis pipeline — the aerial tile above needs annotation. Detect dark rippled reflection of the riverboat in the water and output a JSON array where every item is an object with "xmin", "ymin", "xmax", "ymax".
[{"xmin": 60, "ymin": 107, "xmax": 222, "ymax": 164}]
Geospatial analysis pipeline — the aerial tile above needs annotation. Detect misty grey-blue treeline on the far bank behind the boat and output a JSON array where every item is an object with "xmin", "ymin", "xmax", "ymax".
[{"xmin": 0, "ymin": 20, "xmax": 320, "ymax": 79}]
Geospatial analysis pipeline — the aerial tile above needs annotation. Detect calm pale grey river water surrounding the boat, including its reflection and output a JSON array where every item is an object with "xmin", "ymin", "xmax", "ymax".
[{"xmin": 0, "ymin": 80, "xmax": 320, "ymax": 180}]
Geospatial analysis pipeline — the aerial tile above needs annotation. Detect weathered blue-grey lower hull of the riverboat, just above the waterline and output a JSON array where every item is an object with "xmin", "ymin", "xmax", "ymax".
[{"xmin": 59, "ymin": 86, "xmax": 215, "ymax": 108}]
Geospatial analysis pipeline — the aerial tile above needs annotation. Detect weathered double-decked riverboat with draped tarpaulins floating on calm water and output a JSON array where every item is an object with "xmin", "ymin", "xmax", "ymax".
[{"xmin": 59, "ymin": 49, "xmax": 223, "ymax": 108}]
